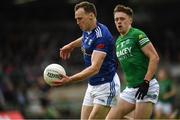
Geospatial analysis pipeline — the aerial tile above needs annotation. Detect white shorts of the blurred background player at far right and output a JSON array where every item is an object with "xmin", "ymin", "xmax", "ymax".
[{"xmin": 155, "ymin": 102, "xmax": 172, "ymax": 115}]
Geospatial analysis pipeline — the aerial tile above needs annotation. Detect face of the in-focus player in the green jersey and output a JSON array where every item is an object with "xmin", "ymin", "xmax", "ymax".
[{"xmin": 114, "ymin": 12, "xmax": 132, "ymax": 35}]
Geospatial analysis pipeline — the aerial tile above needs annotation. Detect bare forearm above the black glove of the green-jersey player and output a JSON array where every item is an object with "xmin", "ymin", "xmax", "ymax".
[{"xmin": 144, "ymin": 55, "xmax": 159, "ymax": 80}]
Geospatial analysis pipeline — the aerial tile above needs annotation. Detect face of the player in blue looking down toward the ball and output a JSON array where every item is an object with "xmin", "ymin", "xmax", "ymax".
[{"xmin": 75, "ymin": 8, "xmax": 92, "ymax": 31}]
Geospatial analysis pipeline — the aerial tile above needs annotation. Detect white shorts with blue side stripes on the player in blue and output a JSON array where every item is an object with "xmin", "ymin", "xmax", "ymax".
[{"xmin": 83, "ymin": 73, "xmax": 120, "ymax": 106}]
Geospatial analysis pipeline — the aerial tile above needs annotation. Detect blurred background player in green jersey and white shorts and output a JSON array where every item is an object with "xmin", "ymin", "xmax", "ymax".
[{"xmin": 154, "ymin": 67, "xmax": 176, "ymax": 119}]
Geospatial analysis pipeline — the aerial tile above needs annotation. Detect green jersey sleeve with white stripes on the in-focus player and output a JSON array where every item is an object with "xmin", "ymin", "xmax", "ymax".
[{"xmin": 137, "ymin": 31, "xmax": 150, "ymax": 48}]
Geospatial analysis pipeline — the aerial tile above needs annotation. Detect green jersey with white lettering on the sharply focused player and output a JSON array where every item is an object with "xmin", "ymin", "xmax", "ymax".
[{"xmin": 116, "ymin": 28, "xmax": 150, "ymax": 87}]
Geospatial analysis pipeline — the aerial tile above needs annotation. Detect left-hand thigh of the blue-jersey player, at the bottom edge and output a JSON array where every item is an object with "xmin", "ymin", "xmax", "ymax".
[{"xmin": 81, "ymin": 105, "xmax": 93, "ymax": 120}]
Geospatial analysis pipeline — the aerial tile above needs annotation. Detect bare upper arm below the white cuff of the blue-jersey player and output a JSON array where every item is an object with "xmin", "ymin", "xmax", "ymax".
[{"xmin": 91, "ymin": 50, "xmax": 106, "ymax": 70}]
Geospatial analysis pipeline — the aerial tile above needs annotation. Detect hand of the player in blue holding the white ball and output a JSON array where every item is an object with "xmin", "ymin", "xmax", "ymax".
[{"xmin": 51, "ymin": 75, "xmax": 70, "ymax": 87}]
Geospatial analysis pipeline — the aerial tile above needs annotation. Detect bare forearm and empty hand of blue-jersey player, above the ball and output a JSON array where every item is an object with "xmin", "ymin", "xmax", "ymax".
[{"xmin": 59, "ymin": 37, "xmax": 82, "ymax": 60}]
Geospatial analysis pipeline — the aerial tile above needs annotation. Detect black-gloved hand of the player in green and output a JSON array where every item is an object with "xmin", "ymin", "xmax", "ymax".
[{"xmin": 135, "ymin": 80, "xmax": 149, "ymax": 100}]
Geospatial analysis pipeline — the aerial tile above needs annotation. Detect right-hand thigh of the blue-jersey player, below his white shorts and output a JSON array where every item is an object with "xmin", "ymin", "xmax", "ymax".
[{"xmin": 89, "ymin": 104, "xmax": 111, "ymax": 119}]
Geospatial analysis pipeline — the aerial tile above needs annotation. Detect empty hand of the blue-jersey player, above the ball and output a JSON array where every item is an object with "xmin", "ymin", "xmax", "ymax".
[{"xmin": 60, "ymin": 45, "xmax": 73, "ymax": 60}]
